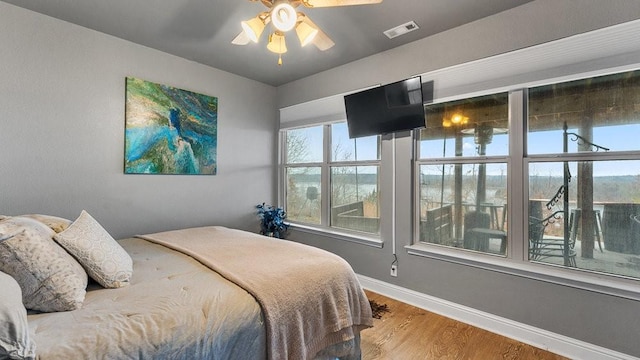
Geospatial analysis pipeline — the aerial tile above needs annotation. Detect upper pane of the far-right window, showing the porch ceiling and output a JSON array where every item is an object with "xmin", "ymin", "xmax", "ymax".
[{"xmin": 527, "ymin": 71, "xmax": 640, "ymax": 154}]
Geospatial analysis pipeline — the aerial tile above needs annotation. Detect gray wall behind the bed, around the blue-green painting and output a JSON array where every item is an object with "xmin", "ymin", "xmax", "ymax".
[{"xmin": 0, "ymin": 2, "xmax": 277, "ymax": 238}]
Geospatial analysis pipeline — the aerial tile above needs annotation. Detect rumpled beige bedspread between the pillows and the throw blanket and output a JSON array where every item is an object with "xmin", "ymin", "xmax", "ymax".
[{"xmin": 27, "ymin": 238, "xmax": 266, "ymax": 360}]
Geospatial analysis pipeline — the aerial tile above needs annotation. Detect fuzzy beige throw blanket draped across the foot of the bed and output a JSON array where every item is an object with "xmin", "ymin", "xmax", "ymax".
[{"xmin": 139, "ymin": 226, "xmax": 373, "ymax": 360}]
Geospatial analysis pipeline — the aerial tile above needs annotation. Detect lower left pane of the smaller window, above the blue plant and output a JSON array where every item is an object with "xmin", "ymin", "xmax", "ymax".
[{"xmin": 286, "ymin": 167, "xmax": 321, "ymax": 224}]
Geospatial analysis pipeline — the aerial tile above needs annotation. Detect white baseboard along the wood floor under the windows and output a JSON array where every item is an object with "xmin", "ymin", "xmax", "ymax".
[{"xmin": 358, "ymin": 275, "xmax": 638, "ymax": 360}]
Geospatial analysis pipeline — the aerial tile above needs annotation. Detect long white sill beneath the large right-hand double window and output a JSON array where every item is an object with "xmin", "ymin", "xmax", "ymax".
[{"xmin": 405, "ymin": 244, "xmax": 640, "ymax": 301}]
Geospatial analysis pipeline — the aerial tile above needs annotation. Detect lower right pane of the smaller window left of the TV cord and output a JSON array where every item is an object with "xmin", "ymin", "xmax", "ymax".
[{"xmin": 331, "ymin": 166, "xmax": 380, "ymax": 234}]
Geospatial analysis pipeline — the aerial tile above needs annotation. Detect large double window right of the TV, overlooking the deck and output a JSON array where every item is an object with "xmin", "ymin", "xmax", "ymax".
[{"xmin": 414, "ymin": 70, "xmax": 640, "ymax": 279}]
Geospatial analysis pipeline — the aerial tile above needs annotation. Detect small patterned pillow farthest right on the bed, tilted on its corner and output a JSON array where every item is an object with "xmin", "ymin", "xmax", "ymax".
[{"xmin": 54, "ymin": 210, "xmax": 133, "ymax": 288}]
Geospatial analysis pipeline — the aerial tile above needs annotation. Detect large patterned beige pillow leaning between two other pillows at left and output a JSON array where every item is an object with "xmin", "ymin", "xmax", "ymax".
[{"xmin": 0, "ymin": 216, "xmax": 88, "ymax": 312}]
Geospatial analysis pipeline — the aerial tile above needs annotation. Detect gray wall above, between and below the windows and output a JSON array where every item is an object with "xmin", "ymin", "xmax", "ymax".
[{"xmin": 278, "ymin": 0, "xmax": 640, "ymax": 357}]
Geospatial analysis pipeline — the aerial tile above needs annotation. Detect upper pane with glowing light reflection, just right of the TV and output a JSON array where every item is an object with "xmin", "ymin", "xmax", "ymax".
[{"xmin": 420, "ymin": 93, "xmax": 509, "ymax": 159}]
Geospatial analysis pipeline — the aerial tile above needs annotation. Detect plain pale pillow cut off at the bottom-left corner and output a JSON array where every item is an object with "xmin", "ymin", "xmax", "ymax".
[{"xmin": 0, "ymin": 272, "xmax": 35, "ymax": 359}]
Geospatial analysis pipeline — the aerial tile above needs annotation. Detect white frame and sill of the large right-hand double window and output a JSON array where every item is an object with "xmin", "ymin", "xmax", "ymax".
[{"xmin": 405, "ymin": 82, "xmax": 640, "ymax": 300}]
